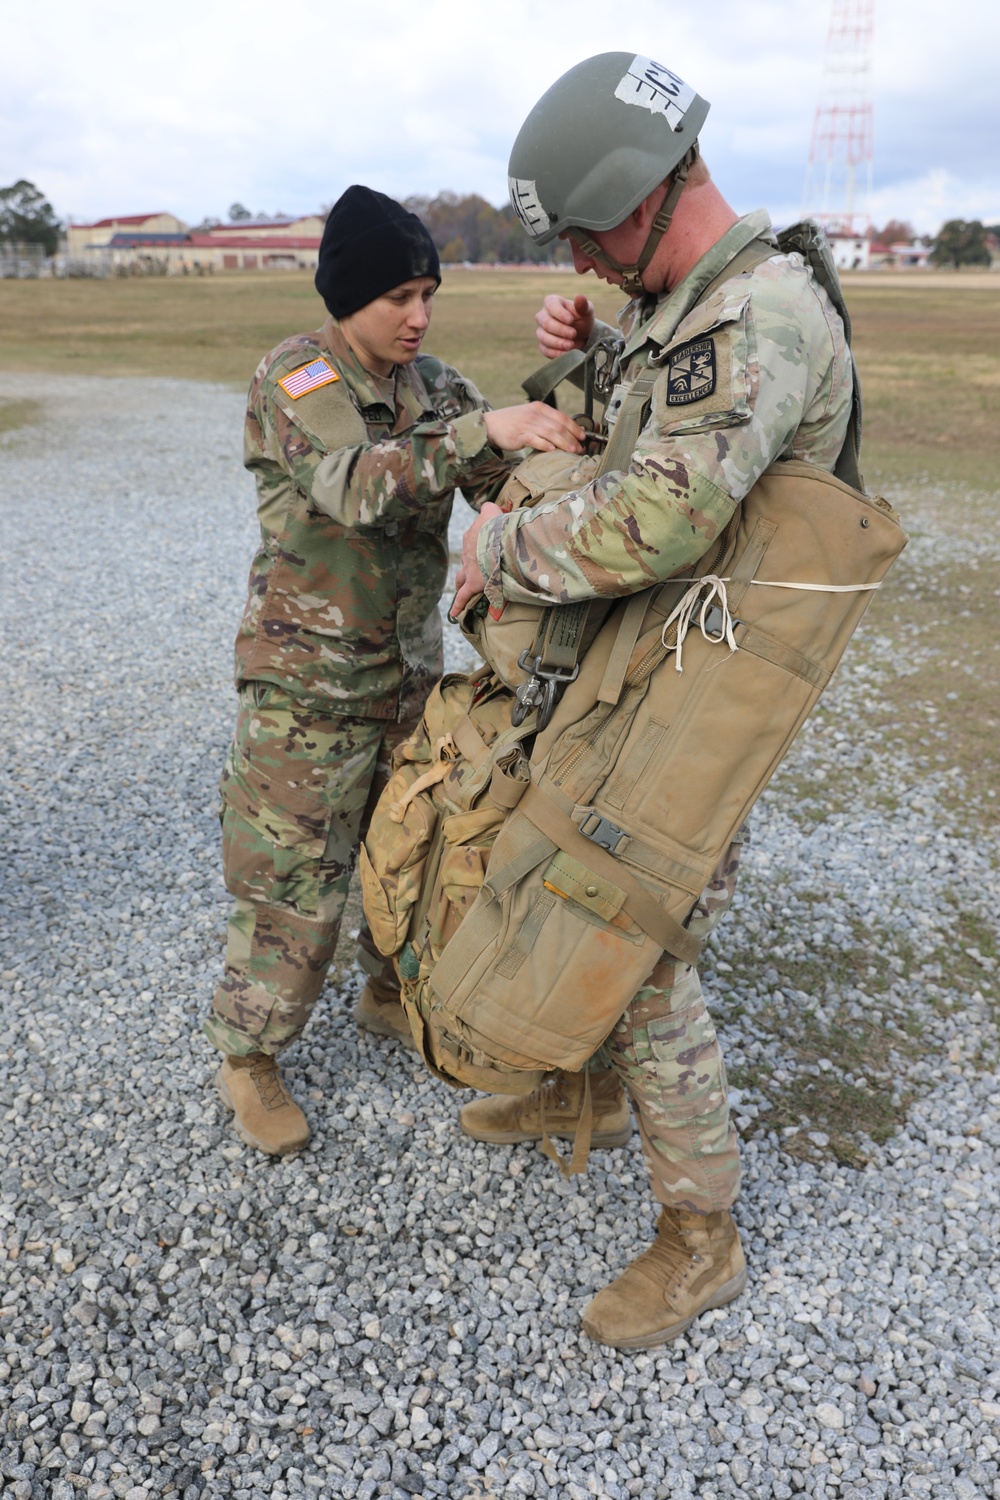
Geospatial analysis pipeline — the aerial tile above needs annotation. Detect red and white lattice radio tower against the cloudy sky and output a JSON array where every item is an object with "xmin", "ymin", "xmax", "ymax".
[{"xmin": 802, "ymin": 0, "xmax": 876, "ymax": 237}]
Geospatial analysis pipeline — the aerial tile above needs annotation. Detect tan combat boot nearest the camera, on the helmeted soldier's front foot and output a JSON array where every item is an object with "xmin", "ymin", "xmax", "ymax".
[{"xmin": 583, "ymin": 1208, "xmax": 747, "ymax": 1349}]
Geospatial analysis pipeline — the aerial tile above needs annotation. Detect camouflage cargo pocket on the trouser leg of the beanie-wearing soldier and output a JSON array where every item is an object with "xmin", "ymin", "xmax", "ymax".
[{"xmin": 220, "ymin": 750, "xmax": 331, "ymax": 917}]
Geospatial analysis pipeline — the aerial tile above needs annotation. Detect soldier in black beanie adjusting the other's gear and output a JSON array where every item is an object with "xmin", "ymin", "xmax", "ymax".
[{"xmin": 205, "ymin": 185, "xmax": 583, "ymax": 1155}]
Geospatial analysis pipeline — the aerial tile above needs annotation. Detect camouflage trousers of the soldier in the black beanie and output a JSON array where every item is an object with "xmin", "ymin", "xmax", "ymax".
[{"xmin": 204, "ymin": 683, "xmax": 414, "ymax": 1056}]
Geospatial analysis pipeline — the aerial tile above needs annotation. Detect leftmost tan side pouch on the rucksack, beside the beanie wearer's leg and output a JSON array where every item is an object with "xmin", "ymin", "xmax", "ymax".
[{"xmin": 358, "ymin": 762, "xmax": 438, "ymax": 957}]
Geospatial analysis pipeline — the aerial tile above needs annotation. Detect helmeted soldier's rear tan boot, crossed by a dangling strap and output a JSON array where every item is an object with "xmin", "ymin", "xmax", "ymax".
[{"xmin": 459, "ymin": 1068, "xmax": 633, "ymax": 1146}]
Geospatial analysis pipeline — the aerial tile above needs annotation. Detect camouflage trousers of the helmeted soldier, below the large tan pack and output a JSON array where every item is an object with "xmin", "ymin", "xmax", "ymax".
[{"xmin": 595, "ymin": 828, "xmax": 745, "ymax": 1214}]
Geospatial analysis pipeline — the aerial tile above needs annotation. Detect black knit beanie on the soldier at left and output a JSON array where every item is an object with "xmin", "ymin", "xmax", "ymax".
[{"xmin": 316, "ymin": 183, "xmax": 441, "ymax": 318}]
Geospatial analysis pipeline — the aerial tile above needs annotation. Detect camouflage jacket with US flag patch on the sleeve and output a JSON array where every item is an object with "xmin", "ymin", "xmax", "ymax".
[{"xmin": 235, "ymin": 318, "xmax": 510, "ymax": 719}]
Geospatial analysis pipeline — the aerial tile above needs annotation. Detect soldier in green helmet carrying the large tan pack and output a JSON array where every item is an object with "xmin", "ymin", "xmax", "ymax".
[{"xmin": 453, "ymin": 53, "xmax": 855, "ymax": 1349}]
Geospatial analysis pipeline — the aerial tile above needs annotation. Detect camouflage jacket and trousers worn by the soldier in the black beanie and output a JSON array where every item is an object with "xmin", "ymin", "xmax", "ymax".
[{"xmin": 205, "ymin": 318, "xmax": 510, "ymax": 1055}]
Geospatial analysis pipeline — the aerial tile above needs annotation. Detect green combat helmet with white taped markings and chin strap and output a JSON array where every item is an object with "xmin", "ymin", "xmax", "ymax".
[{"xmin": 508, "ymin": 53, "xmax": 709, "ymax": 296}]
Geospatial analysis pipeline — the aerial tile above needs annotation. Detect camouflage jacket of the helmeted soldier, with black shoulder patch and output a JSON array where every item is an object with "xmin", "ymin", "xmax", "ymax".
[{"xmin": 478, "ymin": 212, "xmax": 853, "ymax": 609}]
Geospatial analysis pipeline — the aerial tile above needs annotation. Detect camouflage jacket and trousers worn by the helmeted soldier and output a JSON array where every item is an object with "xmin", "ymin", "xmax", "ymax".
[{"xmin": 478, "ymin": 213, "xmax": 853, "ymax": 1212}]
